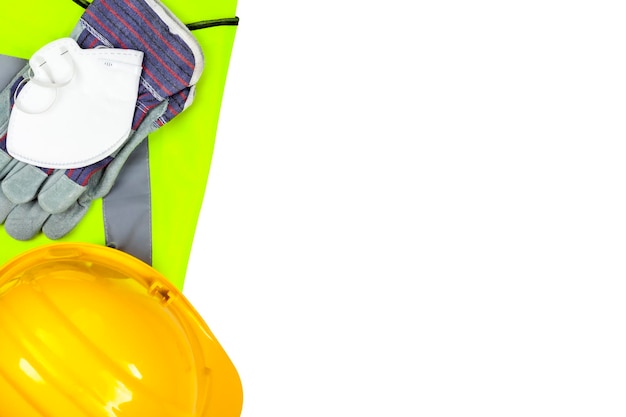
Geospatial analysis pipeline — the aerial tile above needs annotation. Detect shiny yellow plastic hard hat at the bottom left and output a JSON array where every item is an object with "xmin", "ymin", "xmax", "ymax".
[{"xmin": 0, "ymin": 243, "xmax": 242, "ymax": 417}]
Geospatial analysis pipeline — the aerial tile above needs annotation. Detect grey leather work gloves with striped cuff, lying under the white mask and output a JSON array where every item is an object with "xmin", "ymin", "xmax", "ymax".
[{"xmin": 0, "ymin": 0, "xmax": 204, "ymax": 240}]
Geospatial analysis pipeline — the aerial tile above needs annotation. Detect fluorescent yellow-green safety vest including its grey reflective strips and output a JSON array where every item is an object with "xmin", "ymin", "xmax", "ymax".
[{"xmin": 0, "ymin": 0, "xmax": 237, "ymax": 289}]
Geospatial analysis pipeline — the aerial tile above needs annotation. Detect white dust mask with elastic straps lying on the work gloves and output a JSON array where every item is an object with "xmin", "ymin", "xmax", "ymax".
[{"xmin": 7, "ymin": 38, "xmax": 143, "ymax": 168}]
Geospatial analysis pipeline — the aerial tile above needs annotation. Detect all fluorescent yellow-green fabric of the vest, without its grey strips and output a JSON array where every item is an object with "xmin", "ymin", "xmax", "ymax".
[{"xmin": 0, "ymin": 0, "xmax": 236, "ymax": 288}]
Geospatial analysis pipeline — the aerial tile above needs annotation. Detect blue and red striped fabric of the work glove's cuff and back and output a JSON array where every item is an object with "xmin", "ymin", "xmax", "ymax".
[{"xmin": 40, "ymin": 0, "xmax": 196, "ymax": 186}]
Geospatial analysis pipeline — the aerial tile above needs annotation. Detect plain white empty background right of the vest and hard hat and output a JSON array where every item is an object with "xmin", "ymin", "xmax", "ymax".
[{"xmin": 185, "ymin": 0, "xmax": 626, "ymax": 417}]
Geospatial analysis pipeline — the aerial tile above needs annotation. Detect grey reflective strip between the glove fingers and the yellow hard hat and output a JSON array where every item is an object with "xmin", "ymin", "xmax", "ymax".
[{"xmin": 103, "ymin": 139, "xmax": 152, "ymax": 265}]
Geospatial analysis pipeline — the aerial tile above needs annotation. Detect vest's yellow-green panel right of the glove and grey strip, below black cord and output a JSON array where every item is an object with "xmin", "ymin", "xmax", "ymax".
[{"xmin": 149, "ymin": 22, "xmax": 236, "ymax": 290}]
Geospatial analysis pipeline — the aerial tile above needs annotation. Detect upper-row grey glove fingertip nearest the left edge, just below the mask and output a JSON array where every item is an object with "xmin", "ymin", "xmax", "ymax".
[{"xmin": 2, "ymin": 162, "xmax": 53, "ymax": 204}]
